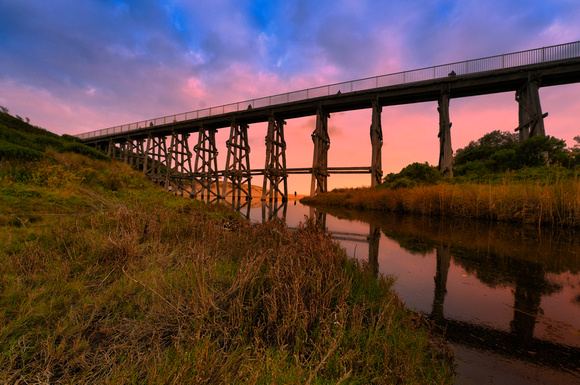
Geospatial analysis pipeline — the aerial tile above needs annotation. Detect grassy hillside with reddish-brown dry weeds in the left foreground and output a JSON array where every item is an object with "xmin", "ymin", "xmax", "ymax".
[{"xmin": 0, "ymin": 110, "xmax": 453, "ymax": 384}]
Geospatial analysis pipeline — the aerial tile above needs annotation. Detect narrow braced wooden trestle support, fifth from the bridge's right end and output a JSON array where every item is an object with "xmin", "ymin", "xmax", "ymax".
[{"xmin": 262, "ymin": 115, "xmax": 288, "ymax": 202}]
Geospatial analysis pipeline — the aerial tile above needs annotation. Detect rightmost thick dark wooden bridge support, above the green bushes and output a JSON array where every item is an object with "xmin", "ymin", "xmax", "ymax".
[{"xmin": 516, "ymin": 74, "xmax": 548, "ymax": 143}]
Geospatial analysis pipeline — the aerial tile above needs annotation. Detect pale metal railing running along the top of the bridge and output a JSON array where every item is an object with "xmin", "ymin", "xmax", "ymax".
[{"xmin": 76, "ymin": 41, "xmax": 580, "ymax": 139}]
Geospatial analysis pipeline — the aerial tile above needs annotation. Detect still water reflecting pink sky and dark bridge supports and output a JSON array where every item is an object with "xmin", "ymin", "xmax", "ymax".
[{"xmin": 241, "ymin": 202, "xmax": 580, "ymax": 385}]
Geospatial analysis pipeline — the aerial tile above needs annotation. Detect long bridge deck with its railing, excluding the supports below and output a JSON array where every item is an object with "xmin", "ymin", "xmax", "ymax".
[{"xmin": 78, "ymin": 42, "xmax": 580, "ymax": 143}]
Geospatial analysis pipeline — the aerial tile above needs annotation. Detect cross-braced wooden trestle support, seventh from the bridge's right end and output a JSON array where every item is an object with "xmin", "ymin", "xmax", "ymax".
[{"xmin": 192, "ymin": 127, "xmax": 220, "ymax": 203}]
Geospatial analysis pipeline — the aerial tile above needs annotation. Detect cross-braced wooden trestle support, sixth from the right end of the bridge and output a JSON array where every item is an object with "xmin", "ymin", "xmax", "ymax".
[{"xmin": 221, "ymin": 122, "xmax": 252, "ymax": 204}]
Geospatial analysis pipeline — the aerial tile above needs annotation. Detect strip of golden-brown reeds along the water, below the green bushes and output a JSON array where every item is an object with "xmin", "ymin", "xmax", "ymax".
[{"xmin": 301, "ymin": 179, "xmax": 580, "ymax": 227}]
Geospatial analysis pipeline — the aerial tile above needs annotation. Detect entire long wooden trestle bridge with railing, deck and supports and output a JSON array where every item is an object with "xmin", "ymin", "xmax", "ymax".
[{"xmin": 77, "ymin": 42, "xmax": 580, "ymax": 202}]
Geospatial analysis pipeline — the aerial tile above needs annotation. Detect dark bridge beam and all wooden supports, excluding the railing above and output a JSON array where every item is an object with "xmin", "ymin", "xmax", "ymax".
[{"xmin": 83, "ymin": 58, "xmax": 580, "ymax": 204}]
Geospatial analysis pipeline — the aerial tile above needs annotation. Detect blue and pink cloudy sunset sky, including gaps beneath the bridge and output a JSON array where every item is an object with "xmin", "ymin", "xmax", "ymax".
[{"xmin": 0, "ymin": 0, "xmax": 580, "ymax": 193}]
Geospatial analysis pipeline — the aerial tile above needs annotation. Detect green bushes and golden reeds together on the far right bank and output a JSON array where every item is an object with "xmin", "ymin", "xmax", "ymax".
[{"xmin": 302, "ymin": 131, "xmax": 580, "ymax": 226}]
